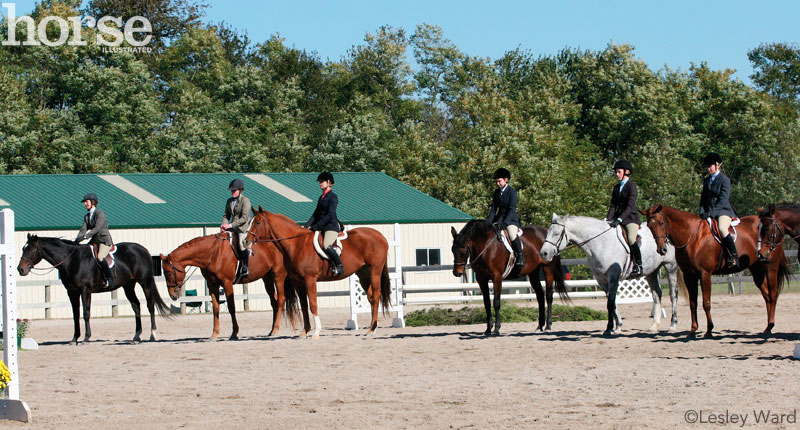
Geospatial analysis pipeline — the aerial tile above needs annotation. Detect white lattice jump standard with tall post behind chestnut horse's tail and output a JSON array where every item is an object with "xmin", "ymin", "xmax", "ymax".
[{"xmin": 347, "ymin": 224, "xmax": 406, "ymax": 330}]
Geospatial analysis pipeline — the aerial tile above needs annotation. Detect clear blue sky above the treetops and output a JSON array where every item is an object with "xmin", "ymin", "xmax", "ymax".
[{"xmin": 2, "ymin": 0, "xmax": 800, "ymax": 83}]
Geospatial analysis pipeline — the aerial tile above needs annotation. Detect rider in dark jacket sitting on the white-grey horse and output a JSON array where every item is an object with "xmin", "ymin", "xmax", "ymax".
[{"xmin": 606, "ymin": 160, "xmax": 643, "ymax": 278}]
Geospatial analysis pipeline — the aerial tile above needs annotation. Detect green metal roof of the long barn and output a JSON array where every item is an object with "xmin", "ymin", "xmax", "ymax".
[{"xmin": 0, "ymin": 172, "xmax": 471, "ymax": 230}]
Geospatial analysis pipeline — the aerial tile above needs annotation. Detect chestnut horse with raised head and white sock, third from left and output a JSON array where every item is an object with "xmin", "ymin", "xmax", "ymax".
[{"xmin": 245, "ymin": 206, "xmax": 391, "ymax": 339}]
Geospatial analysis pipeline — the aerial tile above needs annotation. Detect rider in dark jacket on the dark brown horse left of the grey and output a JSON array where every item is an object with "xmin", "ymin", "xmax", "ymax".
[{"xmin": 488, "ymin": 167, "xmax": 525, "ymax": 266}]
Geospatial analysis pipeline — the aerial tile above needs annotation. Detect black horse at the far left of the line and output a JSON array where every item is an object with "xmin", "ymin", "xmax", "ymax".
[{"xmin": 17, "ymin": 234, "xmax": 171, "ymax": 345}]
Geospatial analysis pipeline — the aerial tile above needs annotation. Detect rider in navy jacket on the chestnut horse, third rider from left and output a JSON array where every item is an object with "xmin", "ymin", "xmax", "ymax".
[{"xmin": 306, "ymin": 172, "xmax": 344, "ymax": 276}]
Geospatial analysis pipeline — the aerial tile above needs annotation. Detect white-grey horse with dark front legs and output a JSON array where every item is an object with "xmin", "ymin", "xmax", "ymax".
[{"xmin": 539, "ymin": 214, "xmax": 679, "ymax": 336}]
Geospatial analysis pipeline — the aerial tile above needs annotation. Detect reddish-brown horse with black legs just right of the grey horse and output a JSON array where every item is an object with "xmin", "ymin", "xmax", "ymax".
[{"xmin": 640, "ymin": 205, "xmax": 789, "ymax": 337}]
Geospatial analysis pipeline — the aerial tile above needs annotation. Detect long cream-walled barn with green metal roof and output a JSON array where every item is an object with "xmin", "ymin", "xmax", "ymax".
[{"xmin": 0, "ymin": 172, "xmax": 471, "ymax": 318}]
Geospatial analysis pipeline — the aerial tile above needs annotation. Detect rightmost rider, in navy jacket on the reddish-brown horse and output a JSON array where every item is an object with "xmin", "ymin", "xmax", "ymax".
[{"xmin": 698, "ymin": 152, "xmax": 739, "ymax": 269}]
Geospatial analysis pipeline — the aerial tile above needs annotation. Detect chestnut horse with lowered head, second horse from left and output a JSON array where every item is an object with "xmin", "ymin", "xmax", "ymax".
[{"xmin": 161, "ymin": 233, "xmax": 297, "ymax": 340}]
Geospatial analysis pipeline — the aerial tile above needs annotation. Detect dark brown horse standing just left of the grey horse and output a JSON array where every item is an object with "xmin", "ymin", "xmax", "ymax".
[{"xmin": 450, "ymin": 219, "xmax": 569, "ymax": 336}]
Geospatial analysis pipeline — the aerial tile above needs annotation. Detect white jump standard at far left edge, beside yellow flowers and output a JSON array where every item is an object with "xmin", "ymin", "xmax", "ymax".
[{"xmin": 0, "ymin": 209, "xmax": 31, "ymax": 422}]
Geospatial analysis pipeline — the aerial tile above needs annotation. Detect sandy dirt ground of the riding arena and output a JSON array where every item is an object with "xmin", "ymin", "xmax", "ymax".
[{"xmin": 6, "ymin": 292, "xmax": 800, "ymax": 430}]
